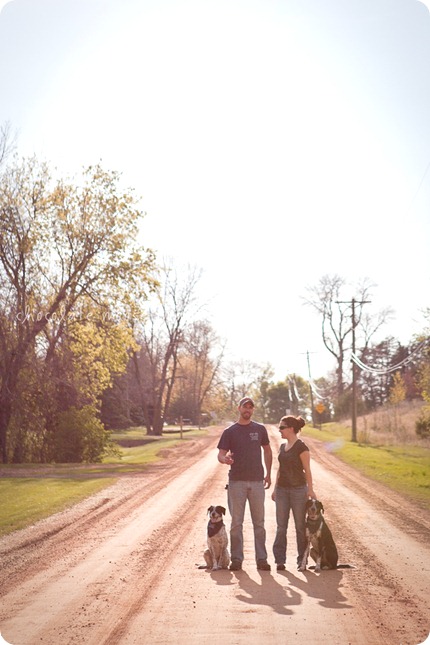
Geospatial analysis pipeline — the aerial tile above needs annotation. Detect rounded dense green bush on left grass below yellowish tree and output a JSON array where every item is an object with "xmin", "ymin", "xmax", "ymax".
[{"xmin": 55, "ymin": 405, "xmax": 110, "ymax": 463}]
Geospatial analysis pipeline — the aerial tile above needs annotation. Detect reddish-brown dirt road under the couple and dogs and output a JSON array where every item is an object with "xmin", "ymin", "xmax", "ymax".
[{"xmin": 0, "ymin": 428, "xmax": 430, "ymax": 645}]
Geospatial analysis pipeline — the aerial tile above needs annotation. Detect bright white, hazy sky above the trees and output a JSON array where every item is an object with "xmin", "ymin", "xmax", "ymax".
[{"xmin": 0, "ymin": 0, "xmax": 430, "ymax": 379}]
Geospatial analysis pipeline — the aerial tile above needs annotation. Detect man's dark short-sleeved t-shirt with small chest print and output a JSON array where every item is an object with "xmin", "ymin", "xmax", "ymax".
[{"xmin": 217, "ymin": 421, "xmax": 269, "ymax": 481}]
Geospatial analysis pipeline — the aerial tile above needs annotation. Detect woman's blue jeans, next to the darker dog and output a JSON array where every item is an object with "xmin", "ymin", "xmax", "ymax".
[{"xmin": 273, "ymin": 486, "xmax": 308, "ymax": 564}]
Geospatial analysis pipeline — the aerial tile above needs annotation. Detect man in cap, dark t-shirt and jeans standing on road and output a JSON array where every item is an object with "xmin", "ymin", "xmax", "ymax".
[{"xmin": 217, "ymin": 396, "xmax": 272, "ymax": 571}]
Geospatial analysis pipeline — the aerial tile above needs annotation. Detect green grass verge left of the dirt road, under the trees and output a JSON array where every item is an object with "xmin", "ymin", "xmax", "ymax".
[{"xmin": 0, "ymin": 429, "xmax": 206, "ymax": 536}]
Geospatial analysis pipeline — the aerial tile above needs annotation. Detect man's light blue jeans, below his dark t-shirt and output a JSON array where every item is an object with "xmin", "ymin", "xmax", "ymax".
[{"xmin": 228, "ymin": 480, "xmax": 267, "ymax": 562}]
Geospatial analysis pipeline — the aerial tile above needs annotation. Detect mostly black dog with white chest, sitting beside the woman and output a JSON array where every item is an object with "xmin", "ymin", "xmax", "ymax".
[{"xmin": 299, "ymin": 499, "xmax": 338, "ymax": 573}]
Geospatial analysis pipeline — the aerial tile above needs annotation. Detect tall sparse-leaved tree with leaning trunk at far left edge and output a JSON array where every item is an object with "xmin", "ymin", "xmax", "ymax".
[{"xmin": 0, "ymin": 158, "xmax": 155, "ymax": 462}]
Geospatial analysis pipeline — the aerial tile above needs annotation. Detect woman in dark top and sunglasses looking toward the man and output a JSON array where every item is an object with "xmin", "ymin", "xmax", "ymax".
[{"xmin": 272, "ymin": 416, "xmax": 316, "ymax": 571}]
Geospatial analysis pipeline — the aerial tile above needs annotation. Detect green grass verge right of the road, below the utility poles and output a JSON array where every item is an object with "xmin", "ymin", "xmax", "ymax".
[{"xmin": 303, "ymin": 423, "xmax": 430, "ymax": 510}]
